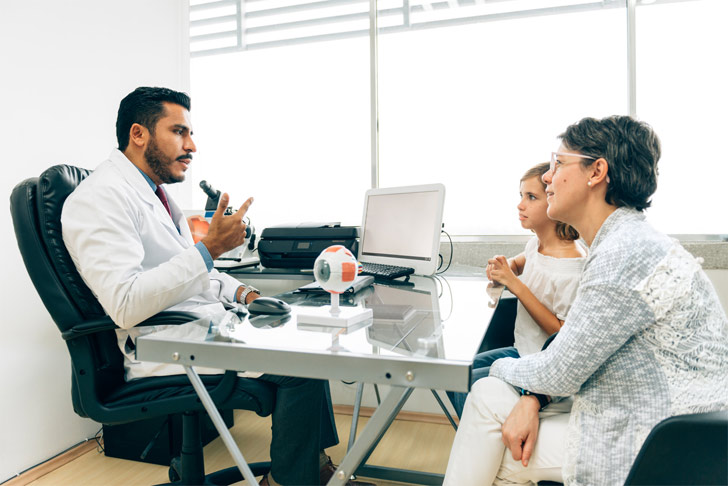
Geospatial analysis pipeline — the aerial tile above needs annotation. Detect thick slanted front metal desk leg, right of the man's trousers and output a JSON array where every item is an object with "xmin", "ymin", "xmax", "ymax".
[{"xmin": 328, "ymin": 386, "xmax": 413, "ymax": 486}]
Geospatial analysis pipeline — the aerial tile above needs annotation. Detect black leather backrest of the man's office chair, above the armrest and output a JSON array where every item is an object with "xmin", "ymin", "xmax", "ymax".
[{"xmin": 10, "ymin": 165, "xmax": 105, "ymax": 332}]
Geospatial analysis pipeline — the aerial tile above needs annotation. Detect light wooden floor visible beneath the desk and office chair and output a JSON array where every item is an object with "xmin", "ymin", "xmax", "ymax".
[{"xmin": 28, "ymin": 410, "xmax": 455, "ymax": 486}]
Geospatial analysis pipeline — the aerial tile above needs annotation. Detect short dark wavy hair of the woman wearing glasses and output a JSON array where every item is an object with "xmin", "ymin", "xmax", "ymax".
[{"xmin": 559, "ymin": 115, "xmax": 662, "ymax": 211}]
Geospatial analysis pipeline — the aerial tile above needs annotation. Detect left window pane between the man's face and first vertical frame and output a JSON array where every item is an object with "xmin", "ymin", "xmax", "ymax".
[{"xmin": 188, "ymin": 1, "xmax": 371, "ymax": 228}]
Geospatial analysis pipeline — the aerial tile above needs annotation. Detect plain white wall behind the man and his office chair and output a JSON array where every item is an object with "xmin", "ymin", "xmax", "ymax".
[{"xmin": 0, "ymin": 0, "xmax": 189, "ymax": 482}]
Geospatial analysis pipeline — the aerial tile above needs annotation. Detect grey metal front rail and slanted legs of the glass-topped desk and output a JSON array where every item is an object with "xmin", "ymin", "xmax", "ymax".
[{"xmin": 137, "ymin": 280, "xmax": 497, "ymax": 486}]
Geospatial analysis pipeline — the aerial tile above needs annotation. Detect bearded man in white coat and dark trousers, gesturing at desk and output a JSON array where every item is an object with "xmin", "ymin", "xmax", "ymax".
[{"xmin": 61, "ymin": 88, "xmax": 362, "ymax": 484}]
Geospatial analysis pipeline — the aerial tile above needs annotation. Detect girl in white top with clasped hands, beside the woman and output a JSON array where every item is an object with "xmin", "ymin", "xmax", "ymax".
[{"xmin": 448, "ymin": 162, "xmax": 586, "ymax": 416}]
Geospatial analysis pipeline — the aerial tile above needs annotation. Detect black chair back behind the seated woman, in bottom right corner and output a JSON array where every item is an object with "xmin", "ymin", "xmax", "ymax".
[{"xmin": 625, "ymin": 410, "xmax": 728, "ymax": 485}]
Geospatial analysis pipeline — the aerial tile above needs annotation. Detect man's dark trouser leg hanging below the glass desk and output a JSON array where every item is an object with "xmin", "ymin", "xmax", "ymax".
[{"xmin": 239, "ymin": 375, "xmax": 339, "ymax": 485}]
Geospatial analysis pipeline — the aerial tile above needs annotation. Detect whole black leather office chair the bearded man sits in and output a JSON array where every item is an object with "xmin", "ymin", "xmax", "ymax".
[{"xmin": 10, "ymin": 165, "xmax": 275, "ymax": 484}]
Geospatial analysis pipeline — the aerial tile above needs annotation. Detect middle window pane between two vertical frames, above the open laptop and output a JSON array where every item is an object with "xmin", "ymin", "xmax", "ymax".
[{"xmin": 379, "ymin": 2, "xmax": 627, "ymax": 235}]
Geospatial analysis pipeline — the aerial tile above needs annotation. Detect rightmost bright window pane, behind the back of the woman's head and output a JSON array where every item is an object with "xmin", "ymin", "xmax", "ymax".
[{"xmin": 636, "ymin": 0, "xmax": 728, "ymax": 234}]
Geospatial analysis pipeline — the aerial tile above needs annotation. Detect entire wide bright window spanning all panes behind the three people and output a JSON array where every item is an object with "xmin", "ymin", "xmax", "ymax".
[{"xmin": 183, "ymin": 0, "xmax": 728, "ymax": 235}]
